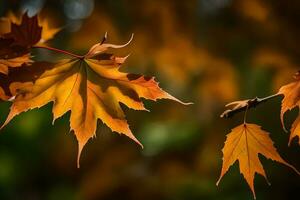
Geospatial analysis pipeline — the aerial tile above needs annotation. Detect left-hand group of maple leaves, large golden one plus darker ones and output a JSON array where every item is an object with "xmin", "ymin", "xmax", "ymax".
[{"xmin": 0, "ymin": 14, "xmax": 188, "ymax": 166}]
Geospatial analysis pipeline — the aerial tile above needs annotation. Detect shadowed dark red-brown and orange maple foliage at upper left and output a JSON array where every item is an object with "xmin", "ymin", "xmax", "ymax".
[{"xmin": 0, "ymin": 13, "xmax": 60, "ymax": 75}]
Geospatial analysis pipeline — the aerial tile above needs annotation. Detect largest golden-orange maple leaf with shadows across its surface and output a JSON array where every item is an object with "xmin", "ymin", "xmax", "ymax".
[{"xmin": 2, "ymin": 37, "xmax": 188, "ymax": 166}]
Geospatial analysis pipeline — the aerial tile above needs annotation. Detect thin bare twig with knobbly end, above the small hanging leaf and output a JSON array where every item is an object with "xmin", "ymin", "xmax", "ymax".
[{"xmin": 220, "ymin": 93, "xmax": 281, "ymax": 118}]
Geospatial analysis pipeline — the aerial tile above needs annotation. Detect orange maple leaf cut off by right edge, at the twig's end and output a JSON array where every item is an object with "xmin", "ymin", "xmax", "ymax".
[{"xmin": 278, "ymin": 72, "xmax": 300, "ymax": 130}]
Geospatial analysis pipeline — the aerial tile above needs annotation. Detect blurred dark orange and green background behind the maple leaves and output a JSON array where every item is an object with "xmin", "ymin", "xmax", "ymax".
[{"xmin": 0, "ymin": 0, "xmax": 300, "ymax": 200}]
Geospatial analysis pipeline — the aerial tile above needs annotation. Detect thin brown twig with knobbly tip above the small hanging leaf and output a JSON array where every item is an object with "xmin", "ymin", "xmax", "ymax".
[{"xmin": 220, "ymin": 93, "xmax": 281, "ymax": 118}]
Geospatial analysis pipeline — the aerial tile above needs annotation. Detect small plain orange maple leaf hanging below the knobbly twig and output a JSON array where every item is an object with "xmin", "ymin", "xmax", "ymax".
[{"xmin": 217, "ymin": 123, "xmax": 299, "ymax": 198}]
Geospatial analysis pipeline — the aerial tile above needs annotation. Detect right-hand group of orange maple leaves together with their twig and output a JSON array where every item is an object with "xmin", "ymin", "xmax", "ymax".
[{"xmin": 217, "ymin": 72, "xmax": 300, "ymax": 198}]
